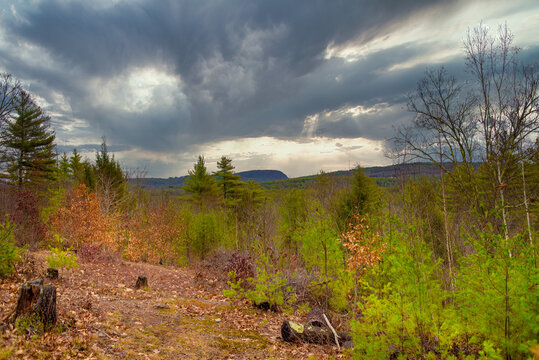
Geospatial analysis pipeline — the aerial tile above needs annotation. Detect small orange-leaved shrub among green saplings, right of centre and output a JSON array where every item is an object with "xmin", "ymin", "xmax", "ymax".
[{"xmin": 340, "ymin": 214, "xmax": 386, "ymax": 272}]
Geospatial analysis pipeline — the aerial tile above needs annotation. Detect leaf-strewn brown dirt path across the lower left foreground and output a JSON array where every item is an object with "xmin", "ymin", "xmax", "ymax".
[{"xmin": 0, "ymin": 255, "xmax": 342, "ymax": 359}]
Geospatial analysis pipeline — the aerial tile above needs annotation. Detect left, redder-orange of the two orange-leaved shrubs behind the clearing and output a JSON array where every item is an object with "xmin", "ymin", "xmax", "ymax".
[{"xmin": 50, "ymin": 185, "xmax": 119, "ymax": 250}]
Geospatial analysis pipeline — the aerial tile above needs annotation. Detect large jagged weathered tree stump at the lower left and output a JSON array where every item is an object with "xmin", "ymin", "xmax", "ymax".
[{"xmin": 13, "ymin": 279, "xmax": 57, "ymax": 331}]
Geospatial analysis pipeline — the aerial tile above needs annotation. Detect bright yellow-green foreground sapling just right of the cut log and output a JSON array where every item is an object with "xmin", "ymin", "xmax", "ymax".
[{"xmin": 351, "ymin": 221, "xmax": 454, "ymax": 359}]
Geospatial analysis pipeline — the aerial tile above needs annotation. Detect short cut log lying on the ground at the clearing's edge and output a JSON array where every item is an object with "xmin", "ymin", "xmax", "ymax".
[{"xmin": 281, "ymin": 320, "xmax": 352, "ymax": 347}]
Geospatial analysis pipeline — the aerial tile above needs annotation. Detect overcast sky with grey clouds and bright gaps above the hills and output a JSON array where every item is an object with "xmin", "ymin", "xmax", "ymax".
[{"xmin": 0, "ymin": 0, "xmax": 539, "ymax": 177}]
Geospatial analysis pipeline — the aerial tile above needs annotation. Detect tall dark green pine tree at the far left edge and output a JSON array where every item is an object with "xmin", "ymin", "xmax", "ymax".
[{"xmin": 2, "ymin": 91, "xmax": 56, "ymax": 188}]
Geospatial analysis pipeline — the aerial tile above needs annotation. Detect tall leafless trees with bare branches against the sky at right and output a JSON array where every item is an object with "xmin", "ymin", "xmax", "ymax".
[{"xmin": 395, "ymin": 24, "xmax": 539, "ymax": 238}]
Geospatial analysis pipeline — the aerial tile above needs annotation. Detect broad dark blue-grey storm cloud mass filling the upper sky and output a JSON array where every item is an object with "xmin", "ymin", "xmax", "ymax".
[{"xmin": 0, "ymin": 0, "xmax": 462, "ymax": 151}]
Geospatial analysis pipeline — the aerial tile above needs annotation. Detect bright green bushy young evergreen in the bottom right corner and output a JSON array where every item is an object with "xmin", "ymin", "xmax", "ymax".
[{"xmin": 455, "ymin": 226, "xmax": 539, "ymax": 358}]
